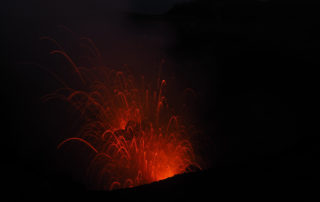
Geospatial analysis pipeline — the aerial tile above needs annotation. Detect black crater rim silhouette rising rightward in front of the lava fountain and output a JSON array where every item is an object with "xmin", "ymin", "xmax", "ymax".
[{"xmin": 52, "ymin": 164, "xmax": 316, "ymax": 201}]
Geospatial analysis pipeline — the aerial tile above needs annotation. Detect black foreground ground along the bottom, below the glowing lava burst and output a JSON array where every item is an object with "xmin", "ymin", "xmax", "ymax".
[{"xmin": 14, "ymin": 166, "xmax": 319, "ymax": 201}]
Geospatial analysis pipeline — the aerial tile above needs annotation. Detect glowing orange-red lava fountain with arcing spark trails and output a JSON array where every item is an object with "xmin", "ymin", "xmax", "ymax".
[{"xmin": 45, "ymin": 34, "xmax": 200, "ymax": 190}]
